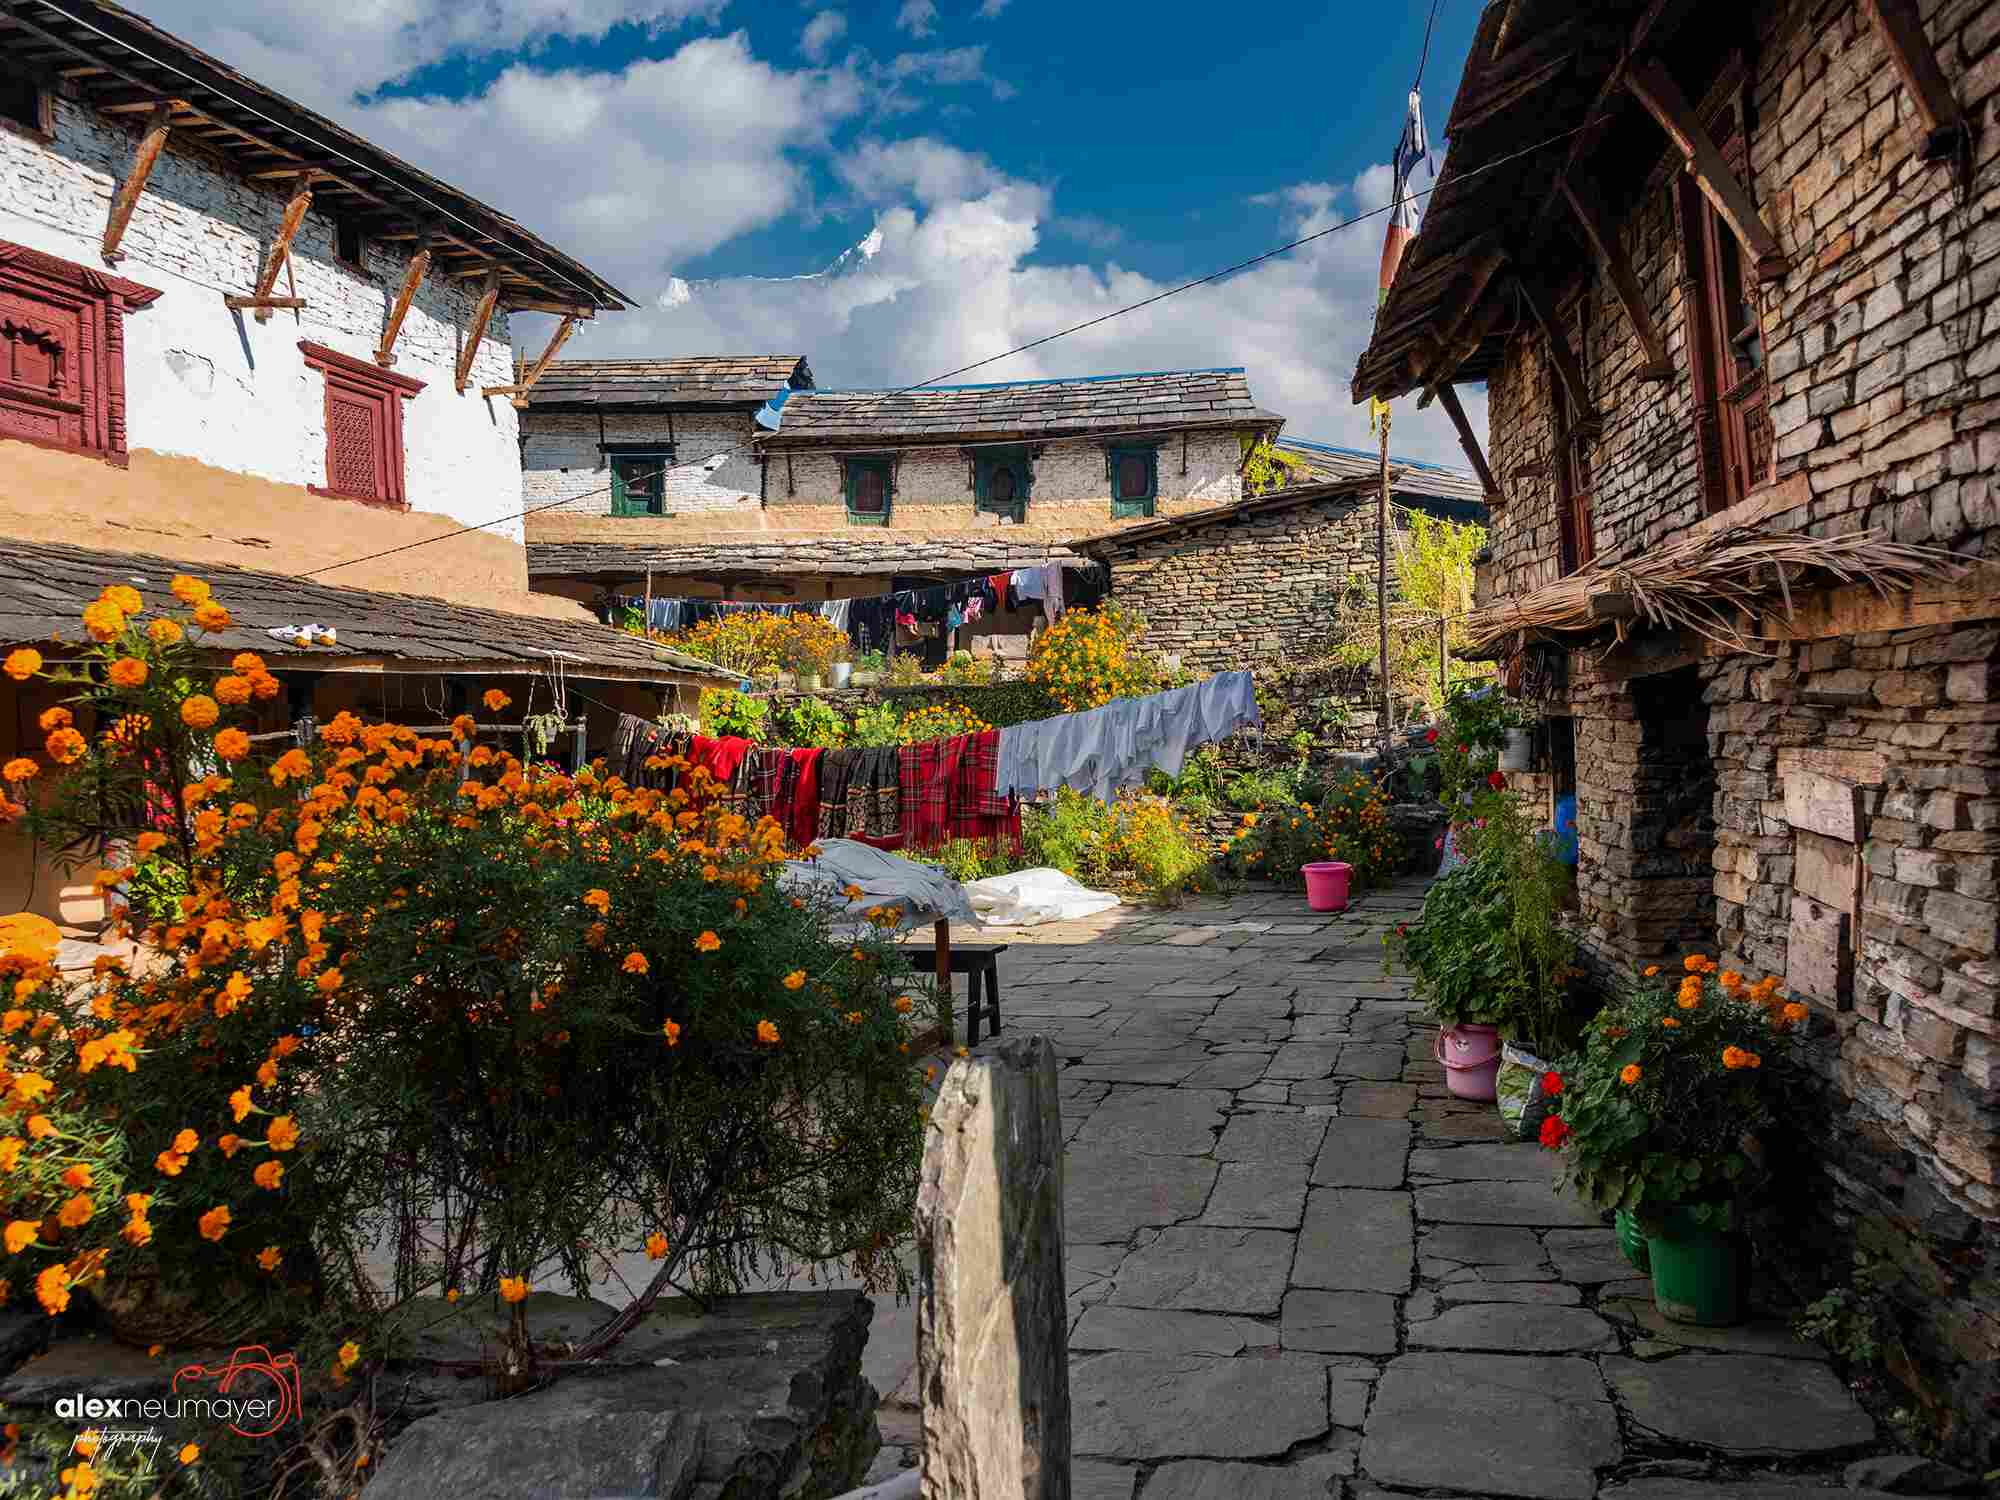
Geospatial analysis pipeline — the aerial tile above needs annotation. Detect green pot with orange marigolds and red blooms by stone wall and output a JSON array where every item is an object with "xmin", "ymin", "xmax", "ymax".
[{"xmin": 1540, "ymin": 954, "xmax": 1806, "ymax": 1324}]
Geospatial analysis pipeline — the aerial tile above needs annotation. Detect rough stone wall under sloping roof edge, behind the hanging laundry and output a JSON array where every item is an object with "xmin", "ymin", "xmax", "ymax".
[{"xmin": 1100, "ymin": 498, "xmax": 1376, "ymax": 670}]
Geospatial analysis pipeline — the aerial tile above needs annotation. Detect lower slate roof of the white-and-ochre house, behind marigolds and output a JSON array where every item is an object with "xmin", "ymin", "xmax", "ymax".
[{"xmin": 0, "ymin": 540, "xmax": 736, "ymax": 682}]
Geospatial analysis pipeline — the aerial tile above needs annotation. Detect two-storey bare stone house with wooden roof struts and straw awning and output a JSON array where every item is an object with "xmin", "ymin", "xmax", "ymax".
[{"xmin": 1354, "ymin": 0, "xmax": 2000, "ymax": 1464}]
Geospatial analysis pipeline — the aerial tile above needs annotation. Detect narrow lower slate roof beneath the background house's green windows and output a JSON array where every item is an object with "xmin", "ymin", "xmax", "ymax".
[{"xmin": 528, "ymin": 534, "xmax": 1082, "ymax": 582}]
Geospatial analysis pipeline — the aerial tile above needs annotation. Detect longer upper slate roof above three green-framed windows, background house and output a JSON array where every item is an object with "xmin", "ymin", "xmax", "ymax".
[{"xmin": 758, "ymin": 368, "xmax": 1282, "ymax": 448}]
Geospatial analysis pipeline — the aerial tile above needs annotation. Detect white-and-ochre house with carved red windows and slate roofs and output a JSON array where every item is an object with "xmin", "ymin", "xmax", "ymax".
[{"xmin": 0, "ymin": 0, "xmax": 736, "ymax": 920}]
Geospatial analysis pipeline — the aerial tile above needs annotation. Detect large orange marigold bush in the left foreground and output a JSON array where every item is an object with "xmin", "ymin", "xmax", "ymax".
[{"xmin": 0, "ymin": 580, "xmax": 922, "ymax": 1448}]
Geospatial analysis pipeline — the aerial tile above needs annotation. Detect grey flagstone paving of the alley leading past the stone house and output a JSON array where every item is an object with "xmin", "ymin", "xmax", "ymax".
[{"xmin": 878, "ymin": 884, "xmax": 1920, "ymax": 1500}]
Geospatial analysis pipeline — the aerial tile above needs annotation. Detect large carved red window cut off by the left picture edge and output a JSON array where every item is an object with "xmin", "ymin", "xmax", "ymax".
[{"xmin": 0, "ymin": 240, "xmax": 160, "ymax": 468}]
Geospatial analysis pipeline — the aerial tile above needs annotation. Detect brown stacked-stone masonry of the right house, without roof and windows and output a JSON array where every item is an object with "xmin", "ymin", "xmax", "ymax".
[{"xmin": 1478, "ymin": 0, "xmax": 2000, "ymax": 1464}]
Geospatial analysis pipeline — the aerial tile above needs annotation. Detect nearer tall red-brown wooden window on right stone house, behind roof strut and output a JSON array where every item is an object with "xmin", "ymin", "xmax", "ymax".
[{"xmin": 1674, "ymin": 52, "xmax": 1776, "ymax": 514}]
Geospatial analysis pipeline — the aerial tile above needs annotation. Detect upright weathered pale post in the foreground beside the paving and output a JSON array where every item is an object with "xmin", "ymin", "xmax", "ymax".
[{"xmin": 916, "ymin": 1036, "xmax": 1070, "ymax": 1500}]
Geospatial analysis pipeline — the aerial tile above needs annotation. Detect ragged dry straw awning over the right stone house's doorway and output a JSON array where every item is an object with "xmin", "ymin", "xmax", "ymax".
[{"xmin": 1466, "ymin": 526, "xmax": 1966, "ymax": 656}]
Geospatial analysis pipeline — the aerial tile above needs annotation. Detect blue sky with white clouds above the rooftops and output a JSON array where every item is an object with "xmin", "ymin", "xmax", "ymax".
[{"xmin": 140, "ymin": 0, "xmax": 1484, "ymax": 462}]
